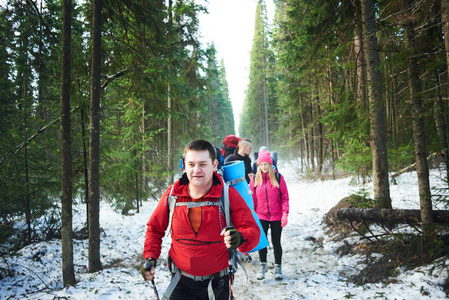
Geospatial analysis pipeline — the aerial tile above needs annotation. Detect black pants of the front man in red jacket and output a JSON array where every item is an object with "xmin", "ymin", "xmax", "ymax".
[{"xmin": 170, "ymin": 275, "xmax": 229, "ymax": 300}]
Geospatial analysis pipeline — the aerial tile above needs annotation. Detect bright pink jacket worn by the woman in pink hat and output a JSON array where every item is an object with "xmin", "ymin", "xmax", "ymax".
[{"xmin": 249, "ymin": 173, "xmax": 289, "ymax": 221}]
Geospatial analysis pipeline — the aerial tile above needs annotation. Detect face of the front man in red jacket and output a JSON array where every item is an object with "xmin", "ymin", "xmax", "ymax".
[{"xmin": 185, "ymin": 150, "xmax": 218, "ymax": 188}]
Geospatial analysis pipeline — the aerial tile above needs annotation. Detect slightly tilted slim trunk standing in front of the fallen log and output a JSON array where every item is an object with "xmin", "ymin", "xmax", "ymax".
[{"xmin": 403, "ymin": 16, "xmax": 433, "ymax": 240}]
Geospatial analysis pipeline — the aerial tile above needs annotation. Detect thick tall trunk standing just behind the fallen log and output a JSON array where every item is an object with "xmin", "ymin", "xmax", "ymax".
[{"xmin": 361, "ymin": 0, "xmax": 391, "ymax": 208}]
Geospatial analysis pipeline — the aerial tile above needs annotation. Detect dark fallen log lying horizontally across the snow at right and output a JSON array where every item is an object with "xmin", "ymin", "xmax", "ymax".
[{"xmin": 337, "ymin": 208, "xmax": 449, "ymax": 224}]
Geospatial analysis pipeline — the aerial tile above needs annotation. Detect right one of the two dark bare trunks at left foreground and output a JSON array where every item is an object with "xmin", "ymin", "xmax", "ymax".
[{"xmin": 89, "ymin": 0, "xmax": 103, "ymax": 273}]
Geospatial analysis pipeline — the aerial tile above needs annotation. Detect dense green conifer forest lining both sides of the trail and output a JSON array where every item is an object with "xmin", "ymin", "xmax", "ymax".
[{"xmin": 0, "ymin": 0, "xmax": 449, "ymax": 284}]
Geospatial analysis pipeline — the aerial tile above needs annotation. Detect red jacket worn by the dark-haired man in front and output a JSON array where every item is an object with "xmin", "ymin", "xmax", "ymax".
[{"xmin": 143, "ymin": 173, "xmax": 260, "ymax": 276}]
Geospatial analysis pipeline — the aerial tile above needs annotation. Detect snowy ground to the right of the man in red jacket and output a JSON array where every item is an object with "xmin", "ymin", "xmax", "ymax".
[{"xmin": 234, "ymin": 166, "xmax": 447, "ymax": 300}]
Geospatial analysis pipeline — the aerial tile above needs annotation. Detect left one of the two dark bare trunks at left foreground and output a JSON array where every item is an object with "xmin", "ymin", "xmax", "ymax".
[{"xmin": 61, "ymin": 0, "xmax": 76, "ymax": 286}]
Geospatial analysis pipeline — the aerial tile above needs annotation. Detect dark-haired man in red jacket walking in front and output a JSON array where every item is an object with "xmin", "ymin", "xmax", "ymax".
[{"xmin": 141, "ymin": 140, "xmax": 260, "ymax": 300}]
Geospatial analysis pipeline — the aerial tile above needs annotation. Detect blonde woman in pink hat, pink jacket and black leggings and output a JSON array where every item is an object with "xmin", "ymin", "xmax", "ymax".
[{"xmin": 250, "ymin": 150, "xmax": 289, "ymax": 280}]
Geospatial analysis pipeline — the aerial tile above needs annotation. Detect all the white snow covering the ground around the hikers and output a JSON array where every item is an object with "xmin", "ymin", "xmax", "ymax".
[{"xmin": 0, "ymin": 164, "xmax": 449, "ymax": 300}]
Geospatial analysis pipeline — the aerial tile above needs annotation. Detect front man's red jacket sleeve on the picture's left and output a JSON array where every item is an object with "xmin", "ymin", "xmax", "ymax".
[{"xmin": 143, "ymin": 186, "xmax": 171, "ymax": 260}]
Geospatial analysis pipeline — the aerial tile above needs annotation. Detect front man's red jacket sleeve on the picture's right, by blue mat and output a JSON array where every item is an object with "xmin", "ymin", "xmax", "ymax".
[{"xmin": 229, "ymin": 187, "xmax": 260, "ymax": 252}]
